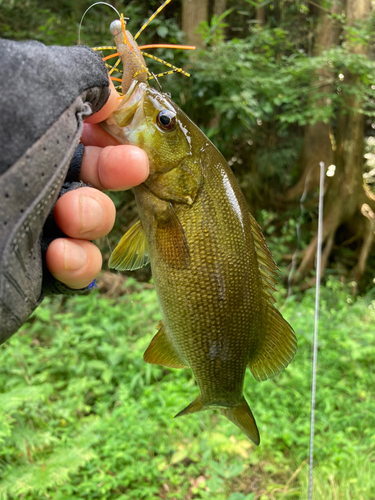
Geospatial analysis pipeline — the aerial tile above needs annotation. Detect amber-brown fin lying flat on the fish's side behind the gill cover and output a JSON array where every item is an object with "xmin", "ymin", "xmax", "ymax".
[{"xmin": 155, "ymin": 203, "xmax": 190, "ymax": 268}]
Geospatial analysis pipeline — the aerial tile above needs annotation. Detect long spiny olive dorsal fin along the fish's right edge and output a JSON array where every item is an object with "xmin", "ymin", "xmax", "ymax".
[{"xmin": 249, "ymin": 214, "xmax": 297, "ymax": 380}]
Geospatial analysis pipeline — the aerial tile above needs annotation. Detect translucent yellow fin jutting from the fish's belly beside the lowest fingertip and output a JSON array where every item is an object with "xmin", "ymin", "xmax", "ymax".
[{"xmin": 108, "ymin": 220, "xmax": 150, "ymax": 271}]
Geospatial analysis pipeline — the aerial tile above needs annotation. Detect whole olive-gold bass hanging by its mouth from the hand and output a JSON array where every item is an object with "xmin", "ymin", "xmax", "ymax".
[{"xmin": 102, "ymin": 15, "xmax": 297, "ymax": 445}]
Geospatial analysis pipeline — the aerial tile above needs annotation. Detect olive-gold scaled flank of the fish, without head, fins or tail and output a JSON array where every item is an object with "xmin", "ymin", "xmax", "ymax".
[{"xmin": 135, "ymin": 141, "xmax": 262, "ymax": 404}]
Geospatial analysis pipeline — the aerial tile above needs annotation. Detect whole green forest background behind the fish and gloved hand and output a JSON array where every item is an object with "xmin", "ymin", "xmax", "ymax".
[{"xmin": 0, "ymin": 0, "xmax": 375, "ymax": 500}]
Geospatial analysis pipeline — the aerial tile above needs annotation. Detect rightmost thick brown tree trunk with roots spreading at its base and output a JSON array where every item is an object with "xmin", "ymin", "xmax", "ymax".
[{"xmin": 298, "ymin": 0, "xmax": 375, "ymax": 280}]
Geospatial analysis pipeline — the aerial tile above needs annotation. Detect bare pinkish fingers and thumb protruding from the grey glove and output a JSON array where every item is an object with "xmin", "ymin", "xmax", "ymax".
[{"xmin": 46, "ymin": 83, "xmax": 148, "ymax": 289}]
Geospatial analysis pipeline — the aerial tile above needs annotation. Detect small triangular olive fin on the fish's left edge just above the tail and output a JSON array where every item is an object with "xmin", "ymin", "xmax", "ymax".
[{"xmin": 143, "ymin": 323, "xmax": 188, "ymax": 368}]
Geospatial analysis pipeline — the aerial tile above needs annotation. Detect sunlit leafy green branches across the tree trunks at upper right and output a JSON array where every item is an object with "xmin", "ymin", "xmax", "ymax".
[{"xmin": 182, "ymin": 28, "xmax": 375, "ymax": 133}]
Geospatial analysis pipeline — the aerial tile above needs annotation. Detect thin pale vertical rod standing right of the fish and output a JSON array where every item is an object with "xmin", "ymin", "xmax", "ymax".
[{"xmin": 308, "ymin": 161, "xmax": 325, "ymax": 500}]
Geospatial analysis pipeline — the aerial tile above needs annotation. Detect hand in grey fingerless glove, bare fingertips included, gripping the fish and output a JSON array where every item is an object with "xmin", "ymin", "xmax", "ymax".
[{"xmin": 0, "ymin": 40, "xmax": 142, "ymax": 344}]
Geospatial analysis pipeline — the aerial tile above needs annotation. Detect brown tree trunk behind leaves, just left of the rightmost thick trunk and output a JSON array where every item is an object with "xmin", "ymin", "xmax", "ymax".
[{"xmin": 287, "ymin": 0, "xmax": 343, "ymax": 200}]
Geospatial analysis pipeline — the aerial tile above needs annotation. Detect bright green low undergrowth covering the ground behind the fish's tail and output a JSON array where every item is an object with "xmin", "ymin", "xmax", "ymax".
[{"xmin": 0, "ymin": 280, "xmax": 375, "ymax": 500}]
